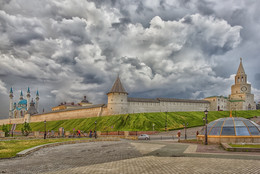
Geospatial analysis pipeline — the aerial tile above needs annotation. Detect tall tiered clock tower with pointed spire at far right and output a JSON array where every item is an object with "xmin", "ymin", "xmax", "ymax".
[{"xmin": 229, "ymin": 58, "xmax": 256, "ymax": 110}]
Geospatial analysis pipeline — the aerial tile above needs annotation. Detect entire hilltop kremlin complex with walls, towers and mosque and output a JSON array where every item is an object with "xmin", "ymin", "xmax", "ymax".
[{"xmin": 0, "ymin": 59, "xmax": 256, "ymax": 125}]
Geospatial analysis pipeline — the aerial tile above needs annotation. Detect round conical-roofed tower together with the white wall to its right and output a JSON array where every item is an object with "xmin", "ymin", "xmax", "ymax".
[{"xmin": 103, "ymin": 77, "xmax": 210, "ymax": 115}]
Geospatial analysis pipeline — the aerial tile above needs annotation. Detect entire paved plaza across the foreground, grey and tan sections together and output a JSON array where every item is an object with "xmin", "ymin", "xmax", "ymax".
[{"xmin": 0, "ymin": 140, "xmax": 260, "ymax": 174}]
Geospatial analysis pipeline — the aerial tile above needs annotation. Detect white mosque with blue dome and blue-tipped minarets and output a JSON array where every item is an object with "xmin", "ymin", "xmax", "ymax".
[{"xmin": 9, "ymin": 87, "xmax": 40, "ymax": 118}]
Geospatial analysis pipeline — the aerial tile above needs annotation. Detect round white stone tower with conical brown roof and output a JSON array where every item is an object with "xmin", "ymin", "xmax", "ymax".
[{"xmin": 107, "ymin": 76, "xmax": 128, "ymax": 115}]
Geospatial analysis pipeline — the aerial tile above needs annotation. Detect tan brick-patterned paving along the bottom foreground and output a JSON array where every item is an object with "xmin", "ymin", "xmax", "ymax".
[{"xmin": 42, "ymin": 156, "xmax": 260, "ymax": 174}]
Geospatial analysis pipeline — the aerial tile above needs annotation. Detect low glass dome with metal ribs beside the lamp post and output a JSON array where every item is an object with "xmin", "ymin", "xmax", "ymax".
[{"xmin": 207, "ymin": 117, "xmax": 260, "ymax": 136}]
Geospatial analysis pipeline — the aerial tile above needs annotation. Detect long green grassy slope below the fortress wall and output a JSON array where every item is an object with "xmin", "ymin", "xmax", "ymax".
[{"xmin": 2, "ymin": 110, "xmax": 260, "ymax": 131}]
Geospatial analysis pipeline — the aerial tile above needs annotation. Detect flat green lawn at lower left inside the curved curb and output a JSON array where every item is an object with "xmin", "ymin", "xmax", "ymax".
[{"xmin": 0, "ymin": 138, "xmax": 85, "ymax": 158}]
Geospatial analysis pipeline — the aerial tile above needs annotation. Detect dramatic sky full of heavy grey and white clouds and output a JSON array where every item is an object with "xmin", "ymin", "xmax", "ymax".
[{"xmin": 0, "ymin": 0, "xmax": 260, "ymax": 118}]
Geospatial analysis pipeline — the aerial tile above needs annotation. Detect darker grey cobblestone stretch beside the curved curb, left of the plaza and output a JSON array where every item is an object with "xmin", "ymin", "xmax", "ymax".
[{"xmin": 0, "ymin": 141, "xmax": 142, "ymax": 174}]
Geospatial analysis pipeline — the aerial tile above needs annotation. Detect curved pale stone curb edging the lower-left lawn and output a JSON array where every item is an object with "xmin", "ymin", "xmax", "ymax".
[{"xmin": 15, "ymin": 138, "xmax": 120, "ymax": 157}]
